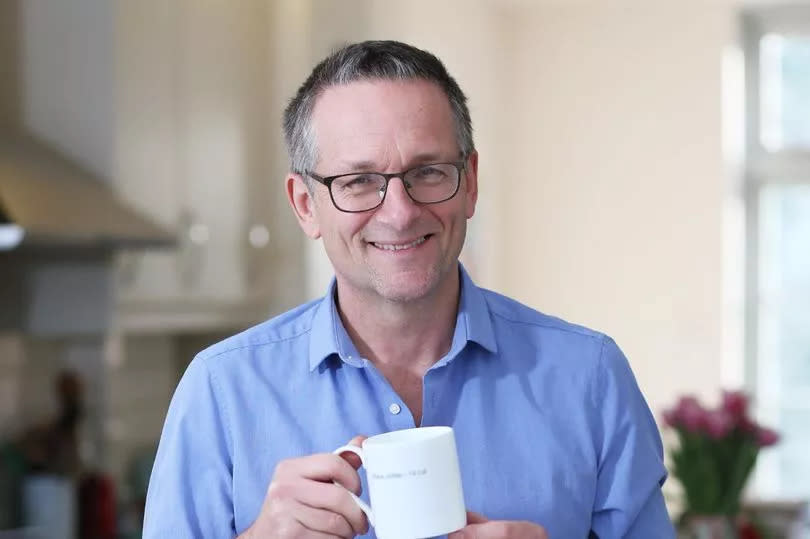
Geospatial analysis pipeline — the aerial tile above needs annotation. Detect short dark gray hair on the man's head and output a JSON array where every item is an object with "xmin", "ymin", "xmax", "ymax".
[{"xmin": 283, "ymin": 41, "xmax": 475, "ymax": 174}]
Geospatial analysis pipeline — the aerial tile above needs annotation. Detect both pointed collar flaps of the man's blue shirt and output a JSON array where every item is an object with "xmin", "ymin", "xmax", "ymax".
[{"xmin": 309, "ymin": 263, "xmax": 498, "ymax": 371}]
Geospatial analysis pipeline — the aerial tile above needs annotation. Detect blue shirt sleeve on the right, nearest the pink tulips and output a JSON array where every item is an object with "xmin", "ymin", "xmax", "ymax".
[{"xmin": 591, "ymin": 337, "xmax": 675, "ymax": 539}]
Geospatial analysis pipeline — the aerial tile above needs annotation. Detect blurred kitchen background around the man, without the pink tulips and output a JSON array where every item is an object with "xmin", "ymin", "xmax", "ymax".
[{"xmin": 0, "ymin": 0, "xmax": 810, "ymax": 537}]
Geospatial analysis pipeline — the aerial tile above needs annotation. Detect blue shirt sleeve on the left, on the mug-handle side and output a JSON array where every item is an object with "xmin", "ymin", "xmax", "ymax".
[{"xmin": 143, "ymin": 356, "xmax": 236, "ymax": 539}]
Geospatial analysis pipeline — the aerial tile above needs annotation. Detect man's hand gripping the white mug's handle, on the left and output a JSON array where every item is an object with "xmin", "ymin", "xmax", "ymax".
[{"xmin": 240, "ymin": 436, "xmax": 368, "ymax": 539}]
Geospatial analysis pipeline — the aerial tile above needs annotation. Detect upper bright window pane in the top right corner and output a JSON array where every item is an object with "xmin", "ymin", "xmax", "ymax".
[{"xmin": 760, "ymin": 34, "xmax": 810, "ymax": 151}]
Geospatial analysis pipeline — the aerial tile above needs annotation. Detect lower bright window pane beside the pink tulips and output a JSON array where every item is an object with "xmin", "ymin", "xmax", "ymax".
[{"xmin": 757, "ymin": 185, "xmax": 810, "ymax": 496}]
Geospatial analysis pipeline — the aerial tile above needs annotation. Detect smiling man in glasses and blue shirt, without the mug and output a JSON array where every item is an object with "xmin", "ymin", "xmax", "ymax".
[{"xmin": 145, "ymin": 41, "xmax": 673, "ymax": 539}]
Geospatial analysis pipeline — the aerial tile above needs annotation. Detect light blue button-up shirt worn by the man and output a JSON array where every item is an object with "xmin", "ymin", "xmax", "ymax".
[{"xmin": 144, "ymin": 268, "xmax": 674, "ymax": 539}]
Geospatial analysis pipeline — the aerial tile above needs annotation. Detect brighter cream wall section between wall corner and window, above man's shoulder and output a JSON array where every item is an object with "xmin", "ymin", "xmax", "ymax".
[{"xmin": 502, "ymin": 2, "xmax": 735, "ymax": 413}]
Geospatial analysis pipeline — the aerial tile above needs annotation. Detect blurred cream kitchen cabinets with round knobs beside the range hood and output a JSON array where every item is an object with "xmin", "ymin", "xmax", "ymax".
[{"xmin": 114, "ymin": 0, "xmax": 305, "ymax": 331}]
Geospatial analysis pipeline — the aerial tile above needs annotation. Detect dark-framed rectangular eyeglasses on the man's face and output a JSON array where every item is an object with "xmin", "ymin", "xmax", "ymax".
[{"xmin": 306, "ymin": 161, "xmax": 464, "ymax": 213}]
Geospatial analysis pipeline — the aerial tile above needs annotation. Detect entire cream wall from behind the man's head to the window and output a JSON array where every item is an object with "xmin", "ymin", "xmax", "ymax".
[{"xmin": 296, "ymin": 0, "xmax": 736, "ymax": 413}]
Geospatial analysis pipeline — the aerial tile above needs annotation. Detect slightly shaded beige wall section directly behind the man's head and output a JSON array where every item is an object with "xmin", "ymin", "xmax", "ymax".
[{"xmin": 296, "ymin": 0, "xmax": 512, "ymax": 297}]
